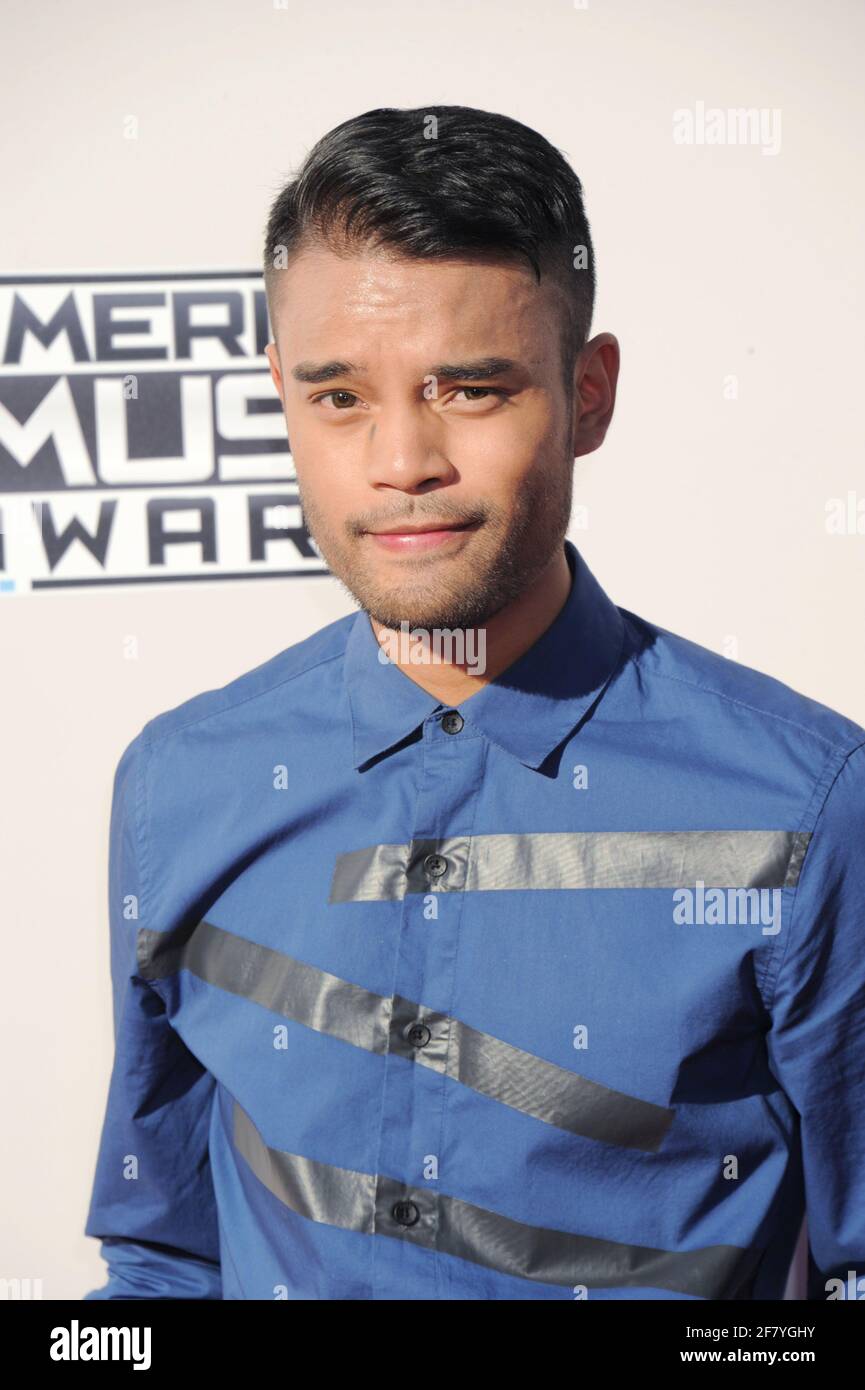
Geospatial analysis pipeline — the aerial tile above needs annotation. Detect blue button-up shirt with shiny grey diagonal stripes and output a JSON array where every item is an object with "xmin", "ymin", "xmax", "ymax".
[{"xmin": 85, "ymin": 541, "xmax": 865, "ymax": 1300}]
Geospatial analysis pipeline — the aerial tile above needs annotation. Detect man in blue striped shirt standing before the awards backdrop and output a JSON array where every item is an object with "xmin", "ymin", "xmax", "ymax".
[{"xmin": 86, "ymin": 107, "xmax": 865, "ymax": 1300}]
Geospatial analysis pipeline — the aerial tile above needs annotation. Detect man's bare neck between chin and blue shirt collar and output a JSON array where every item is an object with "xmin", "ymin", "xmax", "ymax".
[{"xmin": 370, "ymin": 546, "xmax": 572, "ymax": 705}]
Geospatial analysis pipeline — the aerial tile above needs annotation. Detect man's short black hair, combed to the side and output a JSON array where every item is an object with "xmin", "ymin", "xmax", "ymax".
[{"xmin": 264, "ymin": 106, "xmax": 595, "ymax": 382}]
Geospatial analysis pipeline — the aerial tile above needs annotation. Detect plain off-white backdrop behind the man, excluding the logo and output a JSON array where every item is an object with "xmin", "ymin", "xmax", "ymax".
[{"xmin": 0, "ymin": 0, "xmax": 865, "ymax": 1298}]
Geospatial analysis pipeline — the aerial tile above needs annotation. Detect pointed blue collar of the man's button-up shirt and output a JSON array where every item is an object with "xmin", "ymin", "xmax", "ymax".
[{"xmin": 343, "ymin": 539, "xmax": 624, "ymax": 769}]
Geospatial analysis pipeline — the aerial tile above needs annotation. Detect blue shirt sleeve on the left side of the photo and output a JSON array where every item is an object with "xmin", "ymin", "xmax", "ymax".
[{"xmin": 83, "ymin": 728, "xmax": 223, "ymax": 1301}]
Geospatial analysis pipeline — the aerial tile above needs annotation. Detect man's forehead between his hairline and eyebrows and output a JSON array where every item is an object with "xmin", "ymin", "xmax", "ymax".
[{"xmin": 273, "ymin": 246, "xmax": 562, "ymax": 357}]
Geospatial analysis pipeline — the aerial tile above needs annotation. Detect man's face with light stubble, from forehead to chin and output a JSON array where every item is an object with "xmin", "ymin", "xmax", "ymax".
[{"xmin": 267, "ymin": 246, "xmax": 595, "ymax": 628}]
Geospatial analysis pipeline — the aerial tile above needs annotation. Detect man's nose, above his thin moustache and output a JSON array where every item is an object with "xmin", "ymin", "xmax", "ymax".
[{"xmin": 367, "ymin": 402, "xmax": 456, "ymax": 492}]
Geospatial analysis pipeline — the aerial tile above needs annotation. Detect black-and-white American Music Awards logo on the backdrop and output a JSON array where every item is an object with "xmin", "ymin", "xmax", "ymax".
[{"xmin": 0, "ymin": 271, "xmax": 330, "ymax": 596}]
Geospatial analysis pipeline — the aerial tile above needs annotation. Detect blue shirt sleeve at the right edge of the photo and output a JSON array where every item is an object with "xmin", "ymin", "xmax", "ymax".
[{"xmin": 766, "ymin": 744, "xmax": 865, "ymax": 1300}]
